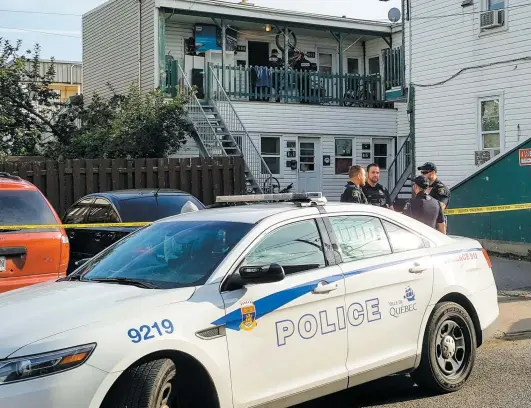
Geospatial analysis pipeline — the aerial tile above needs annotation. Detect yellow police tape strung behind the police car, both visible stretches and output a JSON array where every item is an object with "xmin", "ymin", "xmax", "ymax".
[{"xmin": 0, "ymin": 203, "xmax": 531, "ymax": 230}]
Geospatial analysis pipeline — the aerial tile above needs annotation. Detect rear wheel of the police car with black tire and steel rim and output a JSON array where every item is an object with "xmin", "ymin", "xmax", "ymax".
[{"xmin": 411, "ymin": 302, "xmax": 477, "ymax": 393}]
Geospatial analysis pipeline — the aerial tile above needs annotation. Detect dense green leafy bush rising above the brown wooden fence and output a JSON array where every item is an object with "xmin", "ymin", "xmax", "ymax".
[{"xmin": 45, "ymin": 85, "xmax": 192, "ymax": 158}]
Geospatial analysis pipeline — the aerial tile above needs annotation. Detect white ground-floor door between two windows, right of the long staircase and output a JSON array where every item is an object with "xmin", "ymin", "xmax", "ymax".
[{"xmin": 298, "ymin": 138, "xmax": 321, "ymax": 193}]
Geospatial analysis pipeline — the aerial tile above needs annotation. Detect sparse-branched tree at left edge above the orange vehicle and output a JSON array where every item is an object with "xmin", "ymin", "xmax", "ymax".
[{"xmin": 0, "ymin": 37, "xmax": 78, "ymax": 155}]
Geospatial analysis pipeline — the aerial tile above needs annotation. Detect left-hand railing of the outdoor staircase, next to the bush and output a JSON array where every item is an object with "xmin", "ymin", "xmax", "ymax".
[{"xmin": 172, "ymin": 61, "xmax": 227, "ymax": 157}]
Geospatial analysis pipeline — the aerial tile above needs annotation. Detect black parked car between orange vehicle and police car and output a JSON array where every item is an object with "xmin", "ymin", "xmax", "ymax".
[{"xmin": 62, "ymin": 189, "xmax": 206, "ymax": 273}]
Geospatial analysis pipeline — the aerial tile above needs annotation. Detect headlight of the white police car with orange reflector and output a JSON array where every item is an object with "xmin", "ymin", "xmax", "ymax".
[{"xmin": 0, "ymin": 343, "xmax": 96, "ymax": 386}]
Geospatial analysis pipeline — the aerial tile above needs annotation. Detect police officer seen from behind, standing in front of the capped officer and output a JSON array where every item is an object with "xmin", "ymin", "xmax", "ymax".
[{"xmin": 404, "ymin": 176, "xmax": 446, "ymax": 234}]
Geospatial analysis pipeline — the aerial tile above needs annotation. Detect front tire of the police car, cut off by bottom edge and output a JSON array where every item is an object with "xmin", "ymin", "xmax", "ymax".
[{"xmin": 102, "ymin": 359, "xmax": 177, "ymax": 408}]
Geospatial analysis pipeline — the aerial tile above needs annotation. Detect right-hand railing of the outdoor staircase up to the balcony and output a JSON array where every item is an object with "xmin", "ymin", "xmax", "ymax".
[{"xmin": 208, "ymin": 64, "xmax": 273, "ymax": 192}]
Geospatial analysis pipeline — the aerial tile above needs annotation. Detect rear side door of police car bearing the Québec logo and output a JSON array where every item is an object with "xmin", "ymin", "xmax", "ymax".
[{"xmin": 329, "ymin": 215, "xmax": 433, "ymax": 380}]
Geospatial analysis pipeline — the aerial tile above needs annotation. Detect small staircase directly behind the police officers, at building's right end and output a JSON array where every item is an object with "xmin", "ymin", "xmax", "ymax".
[{"xmin": 388, "ymin": 136, "xmax": 413, "ymax": 210}]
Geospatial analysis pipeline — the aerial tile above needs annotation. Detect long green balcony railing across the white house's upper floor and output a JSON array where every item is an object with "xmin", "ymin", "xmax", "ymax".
[{"xmin": 207, "ymin": 65, "xmax": 391, "ymax": 107}]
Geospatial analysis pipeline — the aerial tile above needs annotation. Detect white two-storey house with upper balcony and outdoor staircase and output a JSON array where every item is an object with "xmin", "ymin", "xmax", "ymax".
[{"xmin": 83, "ymin": 0, "xmax": 411, "ymax": 199}]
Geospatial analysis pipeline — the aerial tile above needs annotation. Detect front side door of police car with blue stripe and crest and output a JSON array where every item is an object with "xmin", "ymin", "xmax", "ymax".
[{"xmin": 222, "ymin": 218, "xmax": 347, "ymax": 408}]
